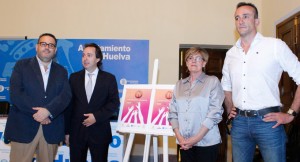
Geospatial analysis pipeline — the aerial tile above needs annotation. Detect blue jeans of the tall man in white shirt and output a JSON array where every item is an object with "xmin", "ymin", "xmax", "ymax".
[{"xmin": 231, "ymin": 115, "xmax": 286, "ymax": 162}]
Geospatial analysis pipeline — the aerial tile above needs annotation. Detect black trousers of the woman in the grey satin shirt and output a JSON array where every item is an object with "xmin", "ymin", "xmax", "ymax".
[{"xmin": 179, "ymin": 144, "xmax": 220, "ymax": 162}]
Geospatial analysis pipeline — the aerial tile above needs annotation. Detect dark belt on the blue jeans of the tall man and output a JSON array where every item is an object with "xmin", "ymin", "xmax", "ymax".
[{"xmin": 236, "ymin": 106, "xmax": 280, "ymax": 117}]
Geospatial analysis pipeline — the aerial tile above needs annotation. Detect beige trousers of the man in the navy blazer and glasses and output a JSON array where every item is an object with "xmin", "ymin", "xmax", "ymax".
[{"xmin": 10, "ymin": 125, "xmax": 58, "ymax": 162}]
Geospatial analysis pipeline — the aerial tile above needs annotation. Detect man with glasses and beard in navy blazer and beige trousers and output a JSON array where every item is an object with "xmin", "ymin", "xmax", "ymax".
[{"xmin": 4, "ymin": 33, "xmax": 72, "ymax": 162}]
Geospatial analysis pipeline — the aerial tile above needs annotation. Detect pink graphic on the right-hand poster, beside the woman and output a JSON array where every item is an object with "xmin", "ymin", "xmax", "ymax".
[{"xmin": 151, "ymin": 89, "xmax": 173, "ymax": 126}]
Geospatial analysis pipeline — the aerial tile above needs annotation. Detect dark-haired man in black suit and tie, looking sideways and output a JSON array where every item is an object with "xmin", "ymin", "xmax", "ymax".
[{"xmin": 65, "ymin": 43, "xmax": 120, "ymax": 162}]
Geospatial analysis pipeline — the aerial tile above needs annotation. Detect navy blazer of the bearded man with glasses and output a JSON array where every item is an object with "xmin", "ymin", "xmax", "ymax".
[{"xmin": 4, "ymin": 57, "xmax": 72, "ymax": 144}]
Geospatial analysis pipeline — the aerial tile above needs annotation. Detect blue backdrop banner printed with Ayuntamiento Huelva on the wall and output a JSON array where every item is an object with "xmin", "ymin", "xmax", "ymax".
[{"xmin": 0, "ymin": 39, "xmax": 149, "ymax": 101}]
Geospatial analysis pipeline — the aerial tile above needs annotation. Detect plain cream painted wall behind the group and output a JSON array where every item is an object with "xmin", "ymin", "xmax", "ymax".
[{"xmin": 0, "ymin": 0, "xmax": 300, "ymax": 158}]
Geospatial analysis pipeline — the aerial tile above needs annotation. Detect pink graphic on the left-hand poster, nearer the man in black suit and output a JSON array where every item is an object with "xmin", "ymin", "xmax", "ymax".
[{"xmin": 121, "ymin": 89, "xmax": 152, "ymax": 124}]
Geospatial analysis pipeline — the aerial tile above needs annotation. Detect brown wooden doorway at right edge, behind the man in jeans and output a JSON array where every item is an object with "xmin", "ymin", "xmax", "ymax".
[{"xmin": 276, "ymin": 12, "xmax": 300, "ymax": 162}]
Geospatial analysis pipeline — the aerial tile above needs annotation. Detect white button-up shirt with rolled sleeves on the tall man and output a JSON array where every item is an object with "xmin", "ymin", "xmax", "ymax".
[{"xmin": 221, "ymin": 33, "xmax": 300, "ymax": 110}]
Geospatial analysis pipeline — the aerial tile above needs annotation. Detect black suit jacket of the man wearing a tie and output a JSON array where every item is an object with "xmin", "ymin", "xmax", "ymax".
[{"xmin": 65, "ymin": 69, "xmax": 120, "ymax": 144}]
